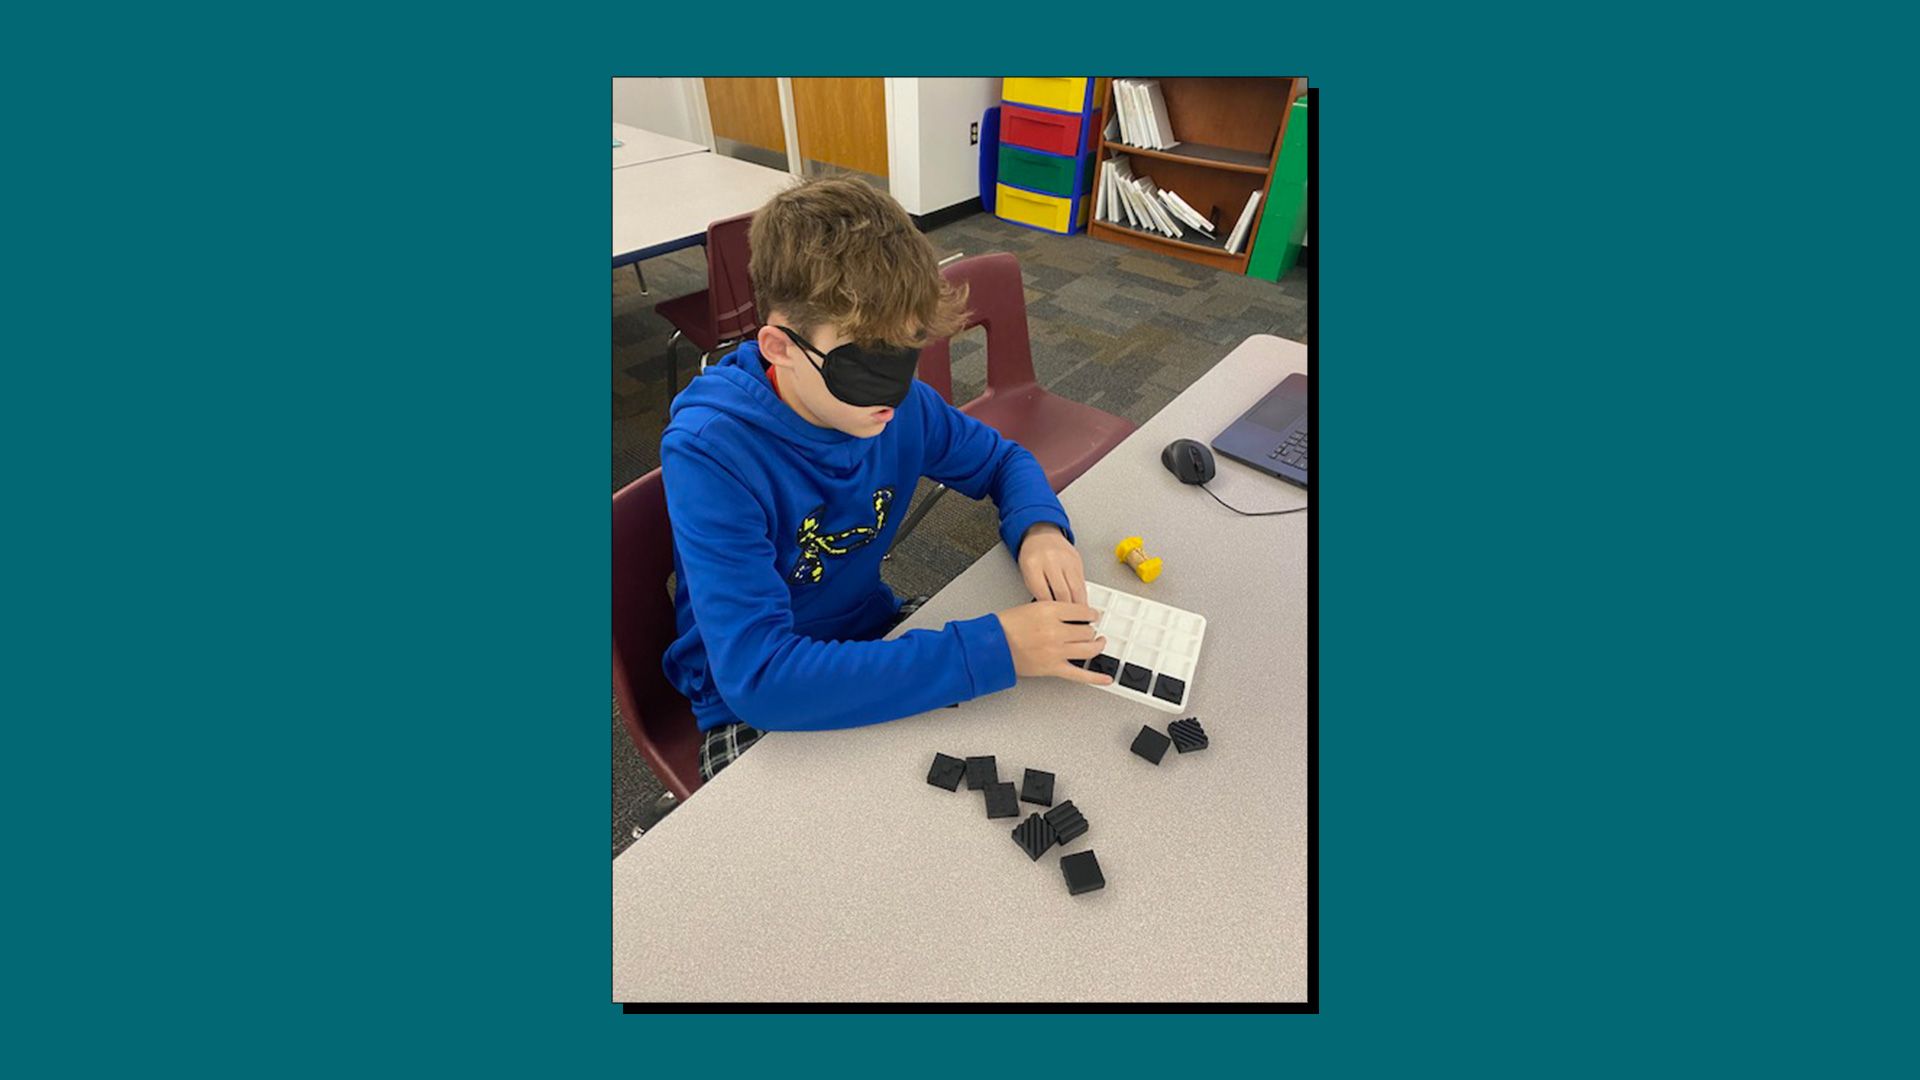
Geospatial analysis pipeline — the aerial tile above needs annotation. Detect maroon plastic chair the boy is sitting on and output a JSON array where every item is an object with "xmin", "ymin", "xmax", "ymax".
[{"xmin": 612, "ymin": 469, "xmax": 701, "ymax": 799}]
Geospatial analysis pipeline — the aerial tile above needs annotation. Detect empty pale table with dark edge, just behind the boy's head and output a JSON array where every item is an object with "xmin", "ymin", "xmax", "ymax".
[{"xmin": 612, "ymin": 154, "xmax": 795, "ymax": 267}]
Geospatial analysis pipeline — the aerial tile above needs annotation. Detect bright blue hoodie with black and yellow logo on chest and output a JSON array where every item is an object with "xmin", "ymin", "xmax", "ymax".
[{"xmin": 660, "ymin": 342, "xmax": 1073, "ymax": 730}]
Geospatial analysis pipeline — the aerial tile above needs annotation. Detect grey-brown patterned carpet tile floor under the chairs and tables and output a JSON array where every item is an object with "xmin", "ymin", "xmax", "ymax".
[{"xmin": 612, "ymin": 213, "xmax": 1309, "ymax": 855}]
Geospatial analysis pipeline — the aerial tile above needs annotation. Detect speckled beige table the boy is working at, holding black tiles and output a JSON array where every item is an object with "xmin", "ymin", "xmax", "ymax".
[{"xmin": 612, "ymin": 334, "xmax": 1313, "ymax": 1003}]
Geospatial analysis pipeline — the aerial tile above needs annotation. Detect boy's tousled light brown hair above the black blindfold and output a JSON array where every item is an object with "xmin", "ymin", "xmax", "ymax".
[{"xmin": 747, "ymin": 177, "xmax": 966, "ymax": 346}]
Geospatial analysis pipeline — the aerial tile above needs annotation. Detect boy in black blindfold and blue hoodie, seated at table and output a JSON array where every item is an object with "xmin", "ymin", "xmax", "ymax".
[{"xmin": 660, "ymin": 177, "xmax": 1112, "ymax": 778}]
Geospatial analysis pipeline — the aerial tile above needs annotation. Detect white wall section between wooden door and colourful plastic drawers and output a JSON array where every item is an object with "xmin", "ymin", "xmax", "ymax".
[{"xmin": 887, "ymin": 79, "xmax": 1000, "ymax": 213}]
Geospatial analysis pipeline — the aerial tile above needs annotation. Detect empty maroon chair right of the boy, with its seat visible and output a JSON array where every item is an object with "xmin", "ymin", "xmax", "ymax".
[{"xmin": 895, "ymin": 252, "xmax": 1133, "ymax": 544}]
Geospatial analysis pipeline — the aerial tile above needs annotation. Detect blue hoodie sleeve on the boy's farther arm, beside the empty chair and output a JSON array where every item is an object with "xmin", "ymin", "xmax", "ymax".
[{"xmin": 914, "ymin": 382, "xmax": 1073, "ymax": 559}]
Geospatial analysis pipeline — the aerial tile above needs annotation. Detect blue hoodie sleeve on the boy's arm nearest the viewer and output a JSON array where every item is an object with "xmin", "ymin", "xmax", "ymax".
[{"xmin": 660, "ymin": 424, "xmax": 1016, "ymax": 730}]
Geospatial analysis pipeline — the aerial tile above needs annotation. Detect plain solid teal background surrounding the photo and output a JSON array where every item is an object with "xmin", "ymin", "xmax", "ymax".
[{"xmin": 11, "ymin": 6, "xmax": 1914, "ymax": 1076}]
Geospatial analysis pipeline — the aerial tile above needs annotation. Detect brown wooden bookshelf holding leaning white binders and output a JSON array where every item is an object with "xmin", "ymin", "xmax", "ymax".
[{"xmin": 1087, "ymin": 75, "xmax": 1306, "ymax": 273}]
